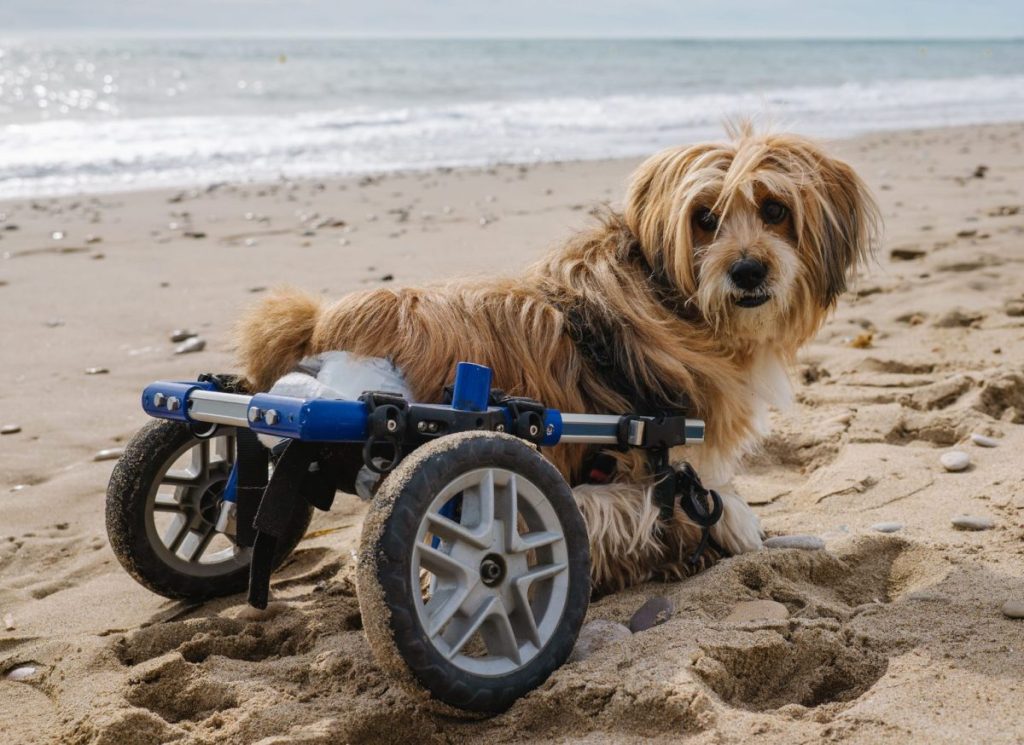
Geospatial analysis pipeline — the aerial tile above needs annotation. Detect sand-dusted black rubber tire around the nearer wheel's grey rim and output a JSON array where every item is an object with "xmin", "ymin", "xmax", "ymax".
[{"xmin": 357, "ymin": 432, "xmax": 590, "ymax": 714}]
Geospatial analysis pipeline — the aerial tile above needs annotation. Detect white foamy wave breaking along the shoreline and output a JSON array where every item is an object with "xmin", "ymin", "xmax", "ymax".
[{"xmin": 0, "ymin": 76, "xmax": 1024, "ymax": 198}]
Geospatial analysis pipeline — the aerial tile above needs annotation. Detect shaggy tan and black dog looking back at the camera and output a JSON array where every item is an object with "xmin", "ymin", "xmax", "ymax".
[{"xmin": 239, "ymin": 126, "xmax": 879, "ymax": 591}]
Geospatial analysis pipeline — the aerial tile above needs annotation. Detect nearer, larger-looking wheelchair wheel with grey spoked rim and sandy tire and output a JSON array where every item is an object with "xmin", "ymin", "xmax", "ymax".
[{"xmin": 357, "ymin": 432, "xmax": 590, "ymax": 713}]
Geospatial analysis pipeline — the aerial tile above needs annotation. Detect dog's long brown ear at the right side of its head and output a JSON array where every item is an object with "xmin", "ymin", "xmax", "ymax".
[{"xmin": 804, "ymin": 155, "xmax": 881, "ymax": 308}]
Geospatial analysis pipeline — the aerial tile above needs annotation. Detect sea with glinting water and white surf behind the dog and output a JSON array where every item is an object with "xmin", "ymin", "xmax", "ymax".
[{"xmin": 0, "ymin": 36, "xmax": 1024, "ymax": 199}]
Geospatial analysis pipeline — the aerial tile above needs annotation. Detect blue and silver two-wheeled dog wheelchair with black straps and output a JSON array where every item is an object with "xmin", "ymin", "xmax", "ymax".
[{"xmin": 106, "ymin": 362, "xmax": 722, "ymax": 713}]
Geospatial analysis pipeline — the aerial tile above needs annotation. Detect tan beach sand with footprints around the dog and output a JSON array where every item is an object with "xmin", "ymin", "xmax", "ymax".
[{"xmin": 0, "ymin": 125, "xmax": 1024, "ymax": 743}]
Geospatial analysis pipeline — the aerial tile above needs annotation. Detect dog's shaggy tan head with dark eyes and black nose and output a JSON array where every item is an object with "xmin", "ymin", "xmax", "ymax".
[{"xmin": 626, "ymin": 125, "xmax": 879, "ymax": 348}]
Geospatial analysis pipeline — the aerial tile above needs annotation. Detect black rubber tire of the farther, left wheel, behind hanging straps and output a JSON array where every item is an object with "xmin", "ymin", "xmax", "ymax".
[{"xmin": 106, "ymin": 420, "xmax": 313, "ymax": 600}]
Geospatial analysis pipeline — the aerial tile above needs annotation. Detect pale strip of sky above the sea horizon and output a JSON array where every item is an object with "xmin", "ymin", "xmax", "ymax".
[{"xmin": 0, "ymin": 0, "xmax": 1024, "ymax": 39}]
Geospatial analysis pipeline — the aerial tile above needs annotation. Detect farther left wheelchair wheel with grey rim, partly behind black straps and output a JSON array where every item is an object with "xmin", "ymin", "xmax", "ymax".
[{"xmin": 106, "ymin": 420, "xmax": 312, "ymax": 600}]
